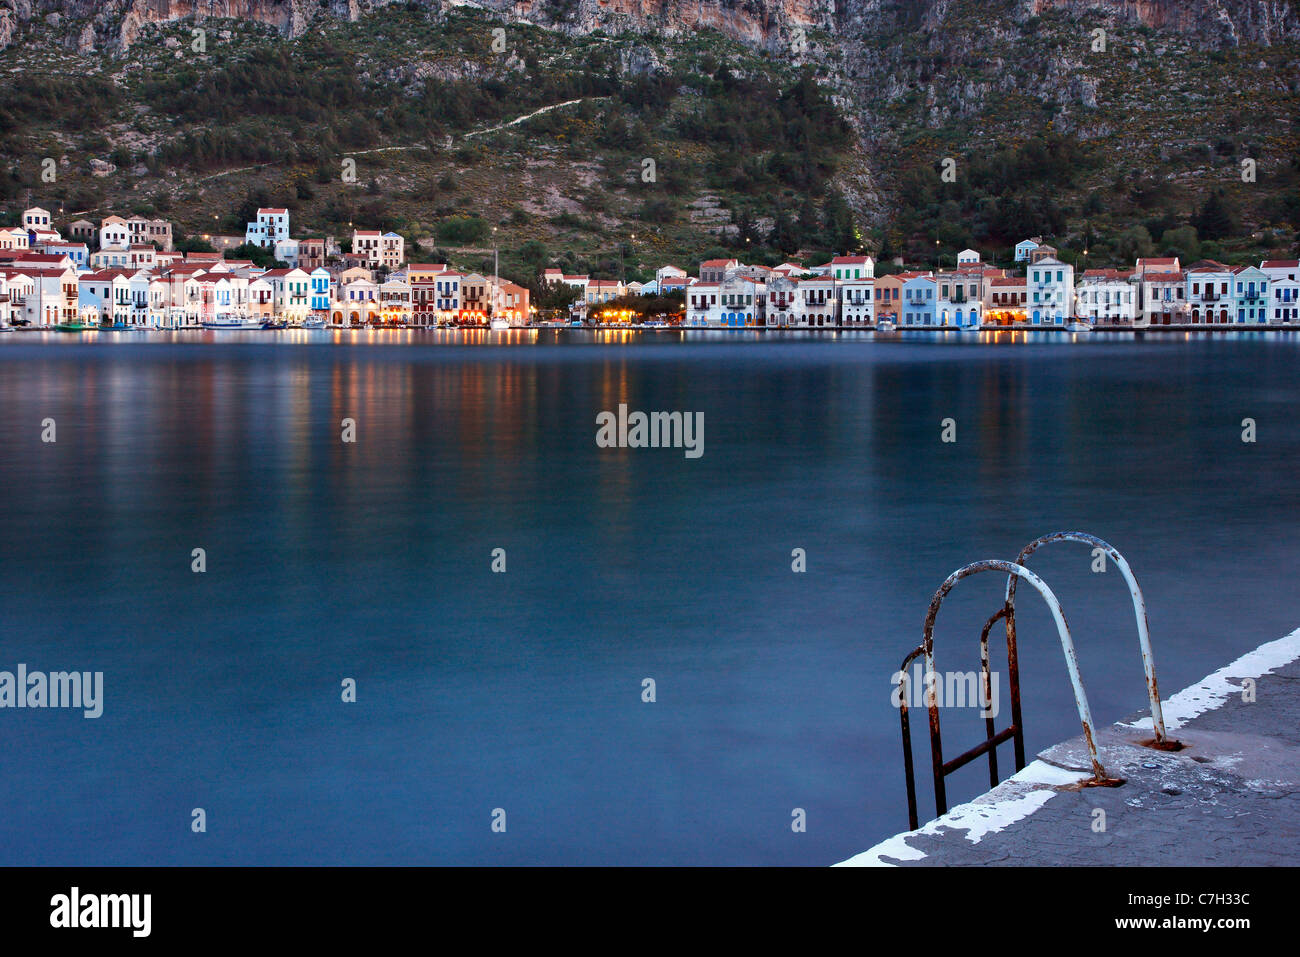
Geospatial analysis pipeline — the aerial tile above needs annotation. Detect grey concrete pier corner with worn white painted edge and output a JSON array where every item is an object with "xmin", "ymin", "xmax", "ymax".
[{"xmin": 842, "ymin": 629, "xmax": 1300, "ymax": 866}]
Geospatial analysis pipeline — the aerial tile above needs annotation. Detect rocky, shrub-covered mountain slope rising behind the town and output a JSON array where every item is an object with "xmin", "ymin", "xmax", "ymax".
[{"xmin": 0, "ymin": 0, "xmax": 1300, "ymax": 280}]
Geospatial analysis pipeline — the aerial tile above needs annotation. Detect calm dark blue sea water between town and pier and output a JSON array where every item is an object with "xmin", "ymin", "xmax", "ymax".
[{"xmin": 0, "ymin": 332, "xmax": 1300, "ymax": 865}]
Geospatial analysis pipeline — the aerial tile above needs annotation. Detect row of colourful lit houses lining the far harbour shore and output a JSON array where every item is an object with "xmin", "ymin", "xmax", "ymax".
[{"xmin": 0, "ymin": 205, "xmax": 1300, "ymax": 333}]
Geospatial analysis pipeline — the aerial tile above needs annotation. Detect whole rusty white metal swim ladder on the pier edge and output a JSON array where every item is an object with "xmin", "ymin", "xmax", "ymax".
[{"xmin": 898, "ymin": 532, "xmax": 1182, "ymax": 831}]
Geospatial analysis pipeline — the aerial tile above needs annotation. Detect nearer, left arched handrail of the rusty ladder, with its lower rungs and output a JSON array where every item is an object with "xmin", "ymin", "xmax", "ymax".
[{"xmin": 898, "ymin": 559, "xmax": 1117, "ymax": 830}]
